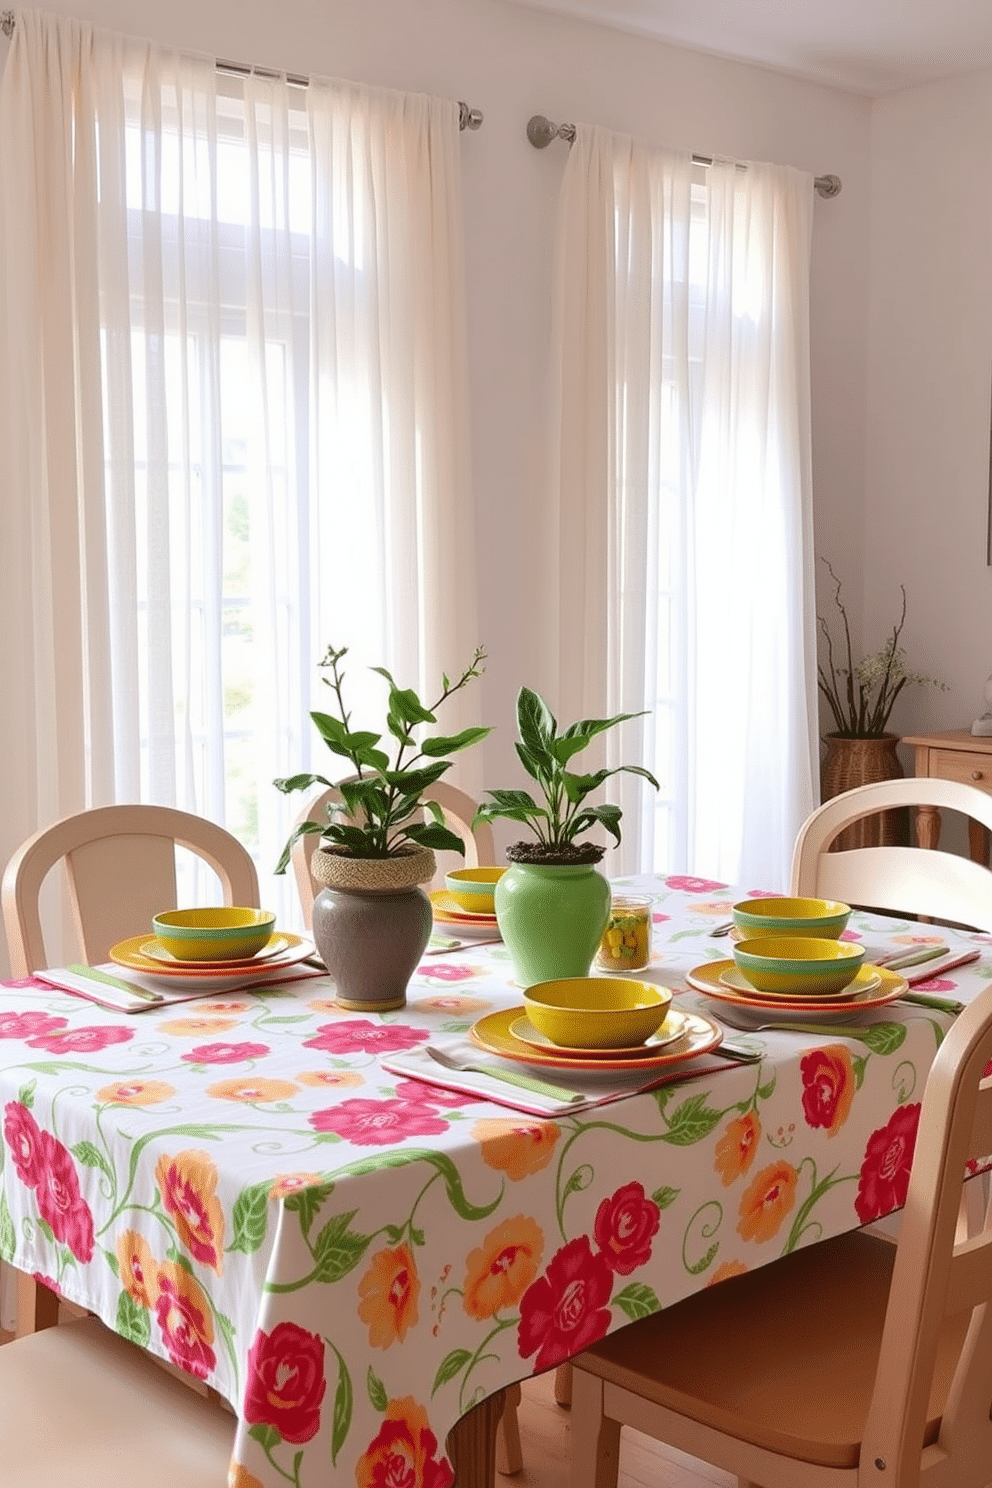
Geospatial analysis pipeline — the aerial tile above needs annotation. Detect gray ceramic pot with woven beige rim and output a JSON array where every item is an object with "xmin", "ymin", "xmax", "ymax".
[{"xmin": 311, "ymin": 848, "xmax": 434, "ymax": 1013}]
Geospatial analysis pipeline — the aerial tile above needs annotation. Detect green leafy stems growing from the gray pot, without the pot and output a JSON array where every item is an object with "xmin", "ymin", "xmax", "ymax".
[{"xmin": 274, "ymin": 646, "xmax": 491, "ymax": 873}]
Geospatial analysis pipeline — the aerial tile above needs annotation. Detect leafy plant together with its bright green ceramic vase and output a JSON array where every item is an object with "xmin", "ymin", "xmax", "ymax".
[{"xmin": 476, "ymin": 687, "xmax": 657, "ymax": 987}]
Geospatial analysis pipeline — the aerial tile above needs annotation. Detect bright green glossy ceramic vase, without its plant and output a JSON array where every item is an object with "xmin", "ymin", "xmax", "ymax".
[{"xmin": 495, "ymin": 863, "xmax": 610, "ymax": 987}]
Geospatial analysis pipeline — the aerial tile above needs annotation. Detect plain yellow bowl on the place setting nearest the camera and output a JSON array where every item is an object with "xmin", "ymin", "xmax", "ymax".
[{"xmin": 524, "ymin": 976, "xmax": 672, "ymax": 1049}]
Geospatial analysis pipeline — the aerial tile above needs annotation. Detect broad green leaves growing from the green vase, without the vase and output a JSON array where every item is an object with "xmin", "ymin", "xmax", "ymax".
[{"xmin": 476, "ymin": 687, "xmax": 659, "ymax": 863}]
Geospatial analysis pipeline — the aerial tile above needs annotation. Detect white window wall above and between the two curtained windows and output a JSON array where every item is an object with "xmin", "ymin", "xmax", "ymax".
[{"xmin": 0, "ymin": 0, "xmax": 868, "ymax": 839}]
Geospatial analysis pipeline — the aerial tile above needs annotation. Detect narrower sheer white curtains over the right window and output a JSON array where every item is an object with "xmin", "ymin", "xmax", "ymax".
[{"xmin": 552, "ymin": 125, "xmax": 817, "ymax": 890}]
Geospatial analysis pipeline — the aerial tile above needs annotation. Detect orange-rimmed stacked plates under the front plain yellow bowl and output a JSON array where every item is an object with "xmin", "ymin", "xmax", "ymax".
[{"xmin": 468, "ymin": 1004, "xmax": 723, "ymax": 1073}]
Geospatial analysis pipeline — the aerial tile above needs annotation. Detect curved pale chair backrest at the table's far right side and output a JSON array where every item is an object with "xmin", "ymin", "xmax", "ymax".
[{"xmin": 791, "ymin": 775, "xmax": 992, "ymax": 930}]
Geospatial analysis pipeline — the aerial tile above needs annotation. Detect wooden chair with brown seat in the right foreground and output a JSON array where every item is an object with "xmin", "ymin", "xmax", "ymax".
[{"xmin": 571, "ymin": 988, "xmax": 992, "ymax": 1488}]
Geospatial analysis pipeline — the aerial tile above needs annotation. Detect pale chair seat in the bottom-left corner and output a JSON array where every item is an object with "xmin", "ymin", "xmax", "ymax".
[{"xmin": 0, "ymin": 1317, "xmax": 235, "ymax": 1488}]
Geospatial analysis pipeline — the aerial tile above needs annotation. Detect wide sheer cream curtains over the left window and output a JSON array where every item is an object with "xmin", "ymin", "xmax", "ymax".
[{"xmin": 0, "ymin": 12, "xmax": 477, "ymax": 940}]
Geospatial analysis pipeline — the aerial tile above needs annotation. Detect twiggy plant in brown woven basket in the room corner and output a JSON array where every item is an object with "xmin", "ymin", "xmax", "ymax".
[{"xmin": 817, "ymin": 558, "xmax": 947, "ymax": 851}]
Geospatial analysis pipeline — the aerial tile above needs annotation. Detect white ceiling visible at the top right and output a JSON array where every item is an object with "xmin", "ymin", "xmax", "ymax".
[{"xmin": 515, "ymin": 0, "xmax": 992, "ymax": 98}]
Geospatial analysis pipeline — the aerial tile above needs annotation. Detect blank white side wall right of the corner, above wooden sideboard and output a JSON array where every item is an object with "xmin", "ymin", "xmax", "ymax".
[{"xmin": 863, "ymin": 71, "xmax": 992, "ymax": 768}]
